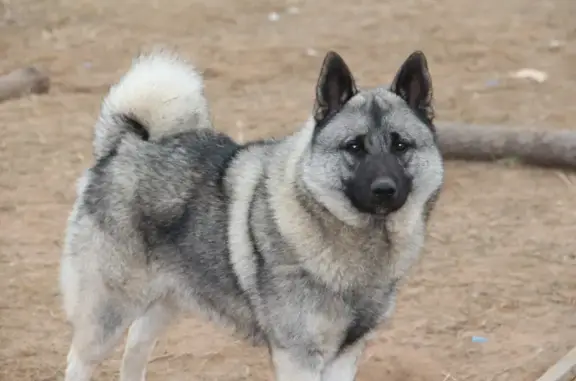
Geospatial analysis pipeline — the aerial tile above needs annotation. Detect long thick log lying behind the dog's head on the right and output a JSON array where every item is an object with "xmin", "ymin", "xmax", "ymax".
[{"xmin": 438, "ymin": 124, "xmax": 576, "ymax": 169}]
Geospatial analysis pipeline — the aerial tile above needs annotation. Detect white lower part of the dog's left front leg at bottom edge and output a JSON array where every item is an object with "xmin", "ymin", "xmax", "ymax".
[{"xmin": 270, "ymin": 347, "xmax": 324, "ymax": 381}]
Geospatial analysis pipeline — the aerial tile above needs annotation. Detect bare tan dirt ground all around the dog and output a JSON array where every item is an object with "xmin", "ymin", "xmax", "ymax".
[{"xmin": 0, "ymin": 0, "xmax": 576, "ymax": 381}]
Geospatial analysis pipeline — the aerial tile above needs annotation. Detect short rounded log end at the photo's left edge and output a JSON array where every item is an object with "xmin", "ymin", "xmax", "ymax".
[{"xmin": 0, "ymin": 67, "xmax": 50, "ymax": 102}]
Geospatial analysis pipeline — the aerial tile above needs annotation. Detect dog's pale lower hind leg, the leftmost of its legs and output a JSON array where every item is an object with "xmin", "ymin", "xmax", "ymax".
[{"xmin": 64, "ymin": 301, "xmax": 131, "ymax": 381}]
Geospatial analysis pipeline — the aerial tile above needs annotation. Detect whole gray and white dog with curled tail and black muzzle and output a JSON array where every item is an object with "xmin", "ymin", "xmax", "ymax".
[{"xmin": 60, "ymin": 51, "xmax": 443, "ymax": 381}]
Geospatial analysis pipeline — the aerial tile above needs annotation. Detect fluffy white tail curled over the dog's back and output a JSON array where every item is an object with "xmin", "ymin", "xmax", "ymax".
[{"xmin": 94, "ymin": 51, "xmax": 212, "ymax": 159}]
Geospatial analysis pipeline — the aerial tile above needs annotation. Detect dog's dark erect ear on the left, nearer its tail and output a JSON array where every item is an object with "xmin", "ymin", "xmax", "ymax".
[{"xmin": 314, "ymin": 51, "xmax": 358, "ymax": 123}]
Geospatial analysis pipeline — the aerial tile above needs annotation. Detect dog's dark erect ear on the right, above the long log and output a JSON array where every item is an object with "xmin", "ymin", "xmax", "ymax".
[{"xmin": 390, "ymin": 51, "xmax": 434, "ymax": 122}]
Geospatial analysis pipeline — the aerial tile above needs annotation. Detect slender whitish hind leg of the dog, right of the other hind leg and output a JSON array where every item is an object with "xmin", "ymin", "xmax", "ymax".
[{"xmin": 120, "ymin": 303, "xmax": 174, "ymax": 381}]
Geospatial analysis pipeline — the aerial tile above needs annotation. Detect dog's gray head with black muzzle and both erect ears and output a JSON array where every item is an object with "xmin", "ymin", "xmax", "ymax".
[{"xmin": 301, "ymin": 52, "xmax": 443, "ymax": 223}]
